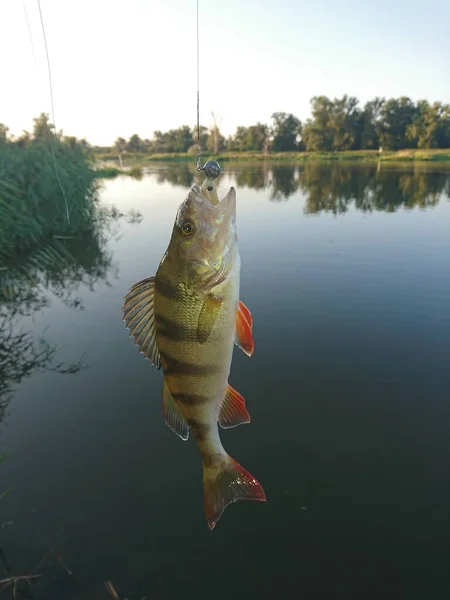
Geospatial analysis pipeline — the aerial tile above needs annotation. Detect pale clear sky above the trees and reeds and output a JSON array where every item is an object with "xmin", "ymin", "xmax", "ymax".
[{"xmin": 0, "ymin": 0, "xmax": 450, "ymax": 145}]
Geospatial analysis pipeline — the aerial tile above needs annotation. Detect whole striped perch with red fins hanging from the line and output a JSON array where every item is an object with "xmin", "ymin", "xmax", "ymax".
[{"xmin": 123, "ymin": 186, "xmax": 265, "ymax": 529}]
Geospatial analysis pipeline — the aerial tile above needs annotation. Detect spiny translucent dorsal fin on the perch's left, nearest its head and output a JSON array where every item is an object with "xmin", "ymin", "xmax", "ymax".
[{"xmin": 122, "ymin": 277, "xmax": 161, "ymax": 369}]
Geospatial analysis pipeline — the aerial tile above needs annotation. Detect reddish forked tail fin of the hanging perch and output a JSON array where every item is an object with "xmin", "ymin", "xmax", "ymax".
[{"xmin": 203, "ymin": 454, "xmax": 266, "ymax": 530}]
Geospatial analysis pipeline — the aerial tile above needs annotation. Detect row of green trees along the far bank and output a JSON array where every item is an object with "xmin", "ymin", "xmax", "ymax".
[{"xmin": 110, "ymin": 95, "xmax": 450, "ymax": 154}]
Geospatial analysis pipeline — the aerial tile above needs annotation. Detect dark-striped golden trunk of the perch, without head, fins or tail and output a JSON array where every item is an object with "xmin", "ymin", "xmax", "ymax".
[{"xmin": 154, "ymin": 254, "xmax": 239, "ymax": 440}]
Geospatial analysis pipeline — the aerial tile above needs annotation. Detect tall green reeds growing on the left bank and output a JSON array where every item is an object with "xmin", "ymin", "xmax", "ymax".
[{"xmin": 0, "ymin": 140, "xmax": 97, "ymax": 268}]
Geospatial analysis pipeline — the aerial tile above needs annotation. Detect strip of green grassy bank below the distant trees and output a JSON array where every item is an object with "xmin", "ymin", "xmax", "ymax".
[{"xmin": 95, "ymin": 149, "xmax": 450, "ymax": 166}]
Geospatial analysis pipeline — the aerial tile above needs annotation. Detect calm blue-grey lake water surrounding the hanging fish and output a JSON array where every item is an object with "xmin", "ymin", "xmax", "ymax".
[{"xmin": 0, "ymin": 165, "xmax": 450, "ymax": 600}]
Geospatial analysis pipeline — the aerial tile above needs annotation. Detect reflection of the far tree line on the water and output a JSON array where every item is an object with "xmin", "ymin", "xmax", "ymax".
[{"xmin": 149, "ymin": 163, "xmax": 450, "ymax": 215}]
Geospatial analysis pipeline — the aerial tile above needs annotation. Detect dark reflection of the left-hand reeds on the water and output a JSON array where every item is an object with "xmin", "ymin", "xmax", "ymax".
[{"xmin": 0, "ymin": 207, "xmax": 141, "ymax": 422}]
